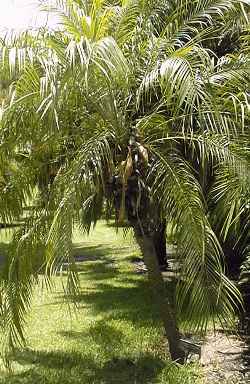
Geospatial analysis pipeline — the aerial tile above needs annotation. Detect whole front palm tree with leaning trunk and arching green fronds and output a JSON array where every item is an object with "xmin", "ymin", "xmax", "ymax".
[{"xmin": 1, "ymin": 0, "xmax": 249, "ymax": 362}]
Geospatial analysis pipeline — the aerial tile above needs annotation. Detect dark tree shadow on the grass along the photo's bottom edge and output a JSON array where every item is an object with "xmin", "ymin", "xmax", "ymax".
[{"xmin": 0, "ymin": 350, "xmax": 165, "ymax": 384}]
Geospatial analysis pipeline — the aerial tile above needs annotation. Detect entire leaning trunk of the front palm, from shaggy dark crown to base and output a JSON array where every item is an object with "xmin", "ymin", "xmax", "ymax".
[{"xmin": 113, "ymin": 128, "xmax": 185, "ymax": 364}]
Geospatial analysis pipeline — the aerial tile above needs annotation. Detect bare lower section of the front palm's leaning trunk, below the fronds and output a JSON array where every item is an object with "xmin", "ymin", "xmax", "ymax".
[{"xmin": 135, "ymin": 229, "xmax": 185, "ymax": 364}]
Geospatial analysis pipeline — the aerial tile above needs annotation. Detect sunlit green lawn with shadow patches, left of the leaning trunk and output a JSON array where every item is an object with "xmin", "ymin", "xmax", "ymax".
[{"xmin": 0, "ymin": 223, "xmax": 202, "ymax": 384}]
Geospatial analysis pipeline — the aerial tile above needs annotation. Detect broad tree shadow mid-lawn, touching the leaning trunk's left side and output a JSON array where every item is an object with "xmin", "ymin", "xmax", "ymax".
[{"xmin": 61, "ymin": 245, "xmax": 159, "ymax": 323}]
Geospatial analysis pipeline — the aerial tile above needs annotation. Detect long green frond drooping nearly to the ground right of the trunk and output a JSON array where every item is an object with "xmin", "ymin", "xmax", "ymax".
[{"xmin": 148, "ymin": 151, "xmax": 240, "ymax": 330}]
